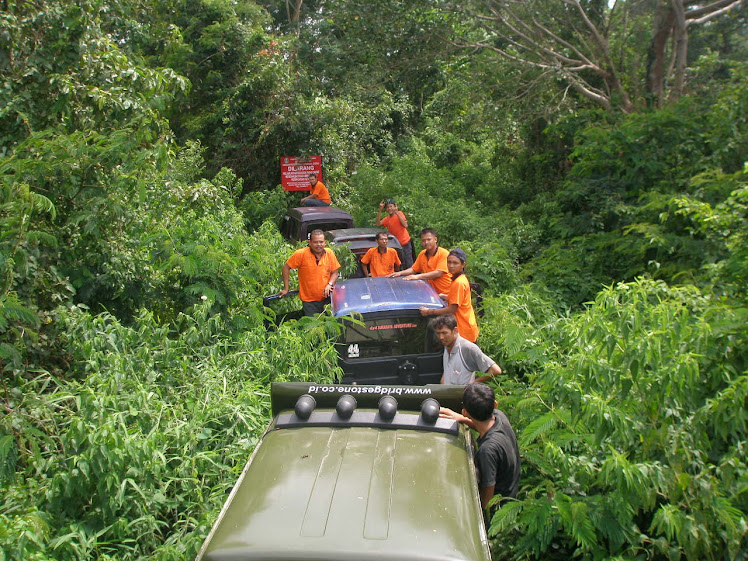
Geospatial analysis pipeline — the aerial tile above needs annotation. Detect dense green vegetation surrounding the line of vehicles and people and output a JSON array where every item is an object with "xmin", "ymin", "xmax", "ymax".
[{"xmin": 0, "ymin": 0, "xmax": 748, "ymax": 561}]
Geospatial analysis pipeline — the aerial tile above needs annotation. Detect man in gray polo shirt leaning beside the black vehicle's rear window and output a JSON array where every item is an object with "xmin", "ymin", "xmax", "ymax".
[{"xmin": 429, "ymin": 314, "xmax": 501, "ymax": 384}]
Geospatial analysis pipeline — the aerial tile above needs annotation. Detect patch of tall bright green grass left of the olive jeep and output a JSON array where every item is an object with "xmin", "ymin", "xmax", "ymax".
[{"xmin": 0, "ymin": 303, "xmax": 338, "ymax": 561}]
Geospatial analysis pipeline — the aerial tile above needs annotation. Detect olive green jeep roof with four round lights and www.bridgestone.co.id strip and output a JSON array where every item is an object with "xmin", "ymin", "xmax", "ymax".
[{"xmin": 197, "ymin": 383, "xmax": 491, "ymax": 561}]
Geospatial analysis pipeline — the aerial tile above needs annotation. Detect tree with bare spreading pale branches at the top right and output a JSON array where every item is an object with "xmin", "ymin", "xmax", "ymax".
[{"xmin": 445, "ymin": 0, "xmax": 746, "ymax": 113}]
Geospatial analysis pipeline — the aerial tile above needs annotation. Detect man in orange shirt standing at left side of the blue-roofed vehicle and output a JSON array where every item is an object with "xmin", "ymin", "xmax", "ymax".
[{"xmin": 278, "ymin": 230, "xmax": 340, "ymax": 316}]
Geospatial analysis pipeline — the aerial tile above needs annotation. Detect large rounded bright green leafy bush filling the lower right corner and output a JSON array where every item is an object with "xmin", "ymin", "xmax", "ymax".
[{"xmin": 490, "ymin": 281, "xmax": 748, "ymax": 560}]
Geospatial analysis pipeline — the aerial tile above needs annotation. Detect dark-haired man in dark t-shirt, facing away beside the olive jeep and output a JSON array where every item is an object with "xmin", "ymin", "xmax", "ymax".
[{"xmin": 440, "ymin": 383, "xmax": 520, "ymax": 509}]
